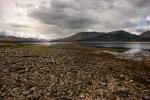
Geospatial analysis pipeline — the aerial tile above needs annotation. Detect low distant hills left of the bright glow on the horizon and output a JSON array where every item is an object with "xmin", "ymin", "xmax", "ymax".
[{"xmin": 0, "ymin": 35, "xmax": 40, "ymax": 42}]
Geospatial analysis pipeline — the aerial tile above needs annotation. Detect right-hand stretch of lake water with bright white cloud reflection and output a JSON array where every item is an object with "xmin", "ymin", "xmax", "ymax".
[{"xmin": 82, "ymin": 42, "xmax": 150, "ymax": 61}]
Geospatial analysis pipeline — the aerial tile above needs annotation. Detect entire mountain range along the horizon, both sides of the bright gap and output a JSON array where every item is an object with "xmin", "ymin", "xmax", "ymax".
[{"xmin": 0, "ymin": 30, "xmax": 150, "ymax": 42}]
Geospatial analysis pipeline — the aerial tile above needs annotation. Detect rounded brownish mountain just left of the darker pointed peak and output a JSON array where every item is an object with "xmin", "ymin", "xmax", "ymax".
[{"xmin": 54, "ymin": 32, "xmax": 105, "ymax": 42}]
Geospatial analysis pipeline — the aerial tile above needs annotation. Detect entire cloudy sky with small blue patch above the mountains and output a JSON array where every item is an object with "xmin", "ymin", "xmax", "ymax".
[{"xmin": 0, "ymin": 0, "xmax": 150, "ymax": 39}]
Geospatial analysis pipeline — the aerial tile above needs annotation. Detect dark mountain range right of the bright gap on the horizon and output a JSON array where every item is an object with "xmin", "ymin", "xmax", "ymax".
[{"xmin": 53, "ymin": 30, "xmax": 150, "ymax": 42}]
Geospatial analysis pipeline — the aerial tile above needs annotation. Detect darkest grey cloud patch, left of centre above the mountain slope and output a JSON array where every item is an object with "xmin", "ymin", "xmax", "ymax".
[{"xmin": 30, "ymin": 0, "xmax": 96, "ymax": 29}]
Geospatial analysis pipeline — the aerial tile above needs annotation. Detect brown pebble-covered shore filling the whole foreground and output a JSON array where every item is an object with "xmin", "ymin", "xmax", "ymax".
[{"xmin": 0, "ymin": 44, "xmax": 150, "ymax": 100}]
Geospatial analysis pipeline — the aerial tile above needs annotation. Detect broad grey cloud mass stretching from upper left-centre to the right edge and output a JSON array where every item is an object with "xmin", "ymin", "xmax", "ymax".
[{"xmin": 29, "ymin": 0, "xmax": 149, "ymax": 35}]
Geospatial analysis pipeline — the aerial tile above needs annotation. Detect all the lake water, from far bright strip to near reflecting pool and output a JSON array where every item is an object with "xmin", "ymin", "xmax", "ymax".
[{"xmin": 24, "ymin": 42, "xmax": 150, "ymax": 61}]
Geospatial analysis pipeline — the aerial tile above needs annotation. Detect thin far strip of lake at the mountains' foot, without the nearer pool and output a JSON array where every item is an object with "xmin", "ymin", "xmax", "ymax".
[{"xmin": 25, "ymin": 42, "xmax": 150, "ymax": 50}]
